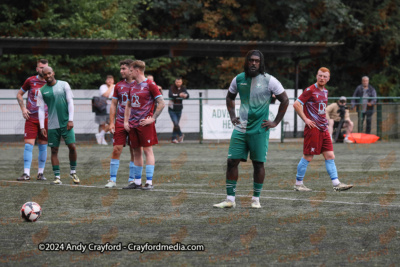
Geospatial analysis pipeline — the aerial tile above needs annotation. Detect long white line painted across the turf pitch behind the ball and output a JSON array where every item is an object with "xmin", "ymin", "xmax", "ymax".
[{"xmin": 2, "ymin": 181, "xmax": 400, "ymax": 208}]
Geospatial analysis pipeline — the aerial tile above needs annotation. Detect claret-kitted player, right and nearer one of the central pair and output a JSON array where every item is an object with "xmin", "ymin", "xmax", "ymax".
[{"xmin": 124, "ymin": 60, "xmax": 165, "ymax": 190}]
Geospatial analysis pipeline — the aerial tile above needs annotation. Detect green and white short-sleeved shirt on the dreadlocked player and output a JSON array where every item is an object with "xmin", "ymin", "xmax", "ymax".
[{"xmin": 229, "ymin": 72, "xmax": 285, "ymax": 134}]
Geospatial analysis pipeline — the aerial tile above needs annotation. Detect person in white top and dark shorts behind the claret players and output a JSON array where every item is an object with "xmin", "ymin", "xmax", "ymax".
[{"xmin": 95, "ymin": 75, "xmax": 115, "ymax": 145}]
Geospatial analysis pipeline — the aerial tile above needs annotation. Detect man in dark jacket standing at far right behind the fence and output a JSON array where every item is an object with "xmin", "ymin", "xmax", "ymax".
[{"xmin": 351, "ymin": 76, "xmax": 376, "ymax": 134}]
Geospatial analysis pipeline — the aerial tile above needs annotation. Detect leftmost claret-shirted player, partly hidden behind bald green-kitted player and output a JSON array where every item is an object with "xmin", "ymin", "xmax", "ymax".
[{"xmin": 17, "ymin": 59, "xmax": 48, "ymax": 181}]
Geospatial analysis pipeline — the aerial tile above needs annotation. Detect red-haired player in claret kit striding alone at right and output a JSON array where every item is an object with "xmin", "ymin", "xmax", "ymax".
[{"xmin": 293, "ymin": 67, "xmax": 353, "ymax": 191}]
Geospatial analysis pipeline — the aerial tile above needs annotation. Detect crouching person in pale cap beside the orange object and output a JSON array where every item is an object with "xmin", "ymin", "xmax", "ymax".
[{"xmin": 325, "ymin": 96, "xmax": 353, "ymax": 143}]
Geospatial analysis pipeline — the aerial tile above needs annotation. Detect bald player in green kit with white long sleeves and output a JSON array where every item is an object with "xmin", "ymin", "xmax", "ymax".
[{"xmin": 37, "ymin": 67, "xmax": 80, "ymax": 185}]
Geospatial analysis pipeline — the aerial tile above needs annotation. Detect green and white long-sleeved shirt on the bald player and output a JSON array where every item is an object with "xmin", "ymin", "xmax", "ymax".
[{"xmin": 37, "ymin": 80, "xmax": 74, "ymax": 130}]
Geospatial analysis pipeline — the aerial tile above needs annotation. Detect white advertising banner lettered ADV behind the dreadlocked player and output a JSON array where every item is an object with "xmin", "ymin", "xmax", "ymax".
[{"xmin": 203, "ymin": 104, "xmax": 281, "ymax": 140}]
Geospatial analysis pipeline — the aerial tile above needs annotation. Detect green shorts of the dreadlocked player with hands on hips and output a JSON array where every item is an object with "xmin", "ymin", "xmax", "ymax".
[{"xmin": 228, "ymin": 130, "xmax": 269, "ymax": 162}]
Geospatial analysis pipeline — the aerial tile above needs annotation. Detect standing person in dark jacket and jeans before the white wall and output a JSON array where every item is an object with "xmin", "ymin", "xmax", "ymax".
[{"xmin": 168, "ymin": 77, "xmax": 189, "ymax": 144}]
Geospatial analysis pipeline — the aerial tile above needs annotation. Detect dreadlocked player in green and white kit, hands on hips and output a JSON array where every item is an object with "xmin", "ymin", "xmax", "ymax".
[{"xmin": 214, "ymin": 50, "xmax": 289, "ymax": 208}]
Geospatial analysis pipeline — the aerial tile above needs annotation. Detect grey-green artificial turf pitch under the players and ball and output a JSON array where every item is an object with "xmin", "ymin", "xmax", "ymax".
[{"xmin": 0, "ymin": 142, "xmax": 400, "ymax": 266}]
